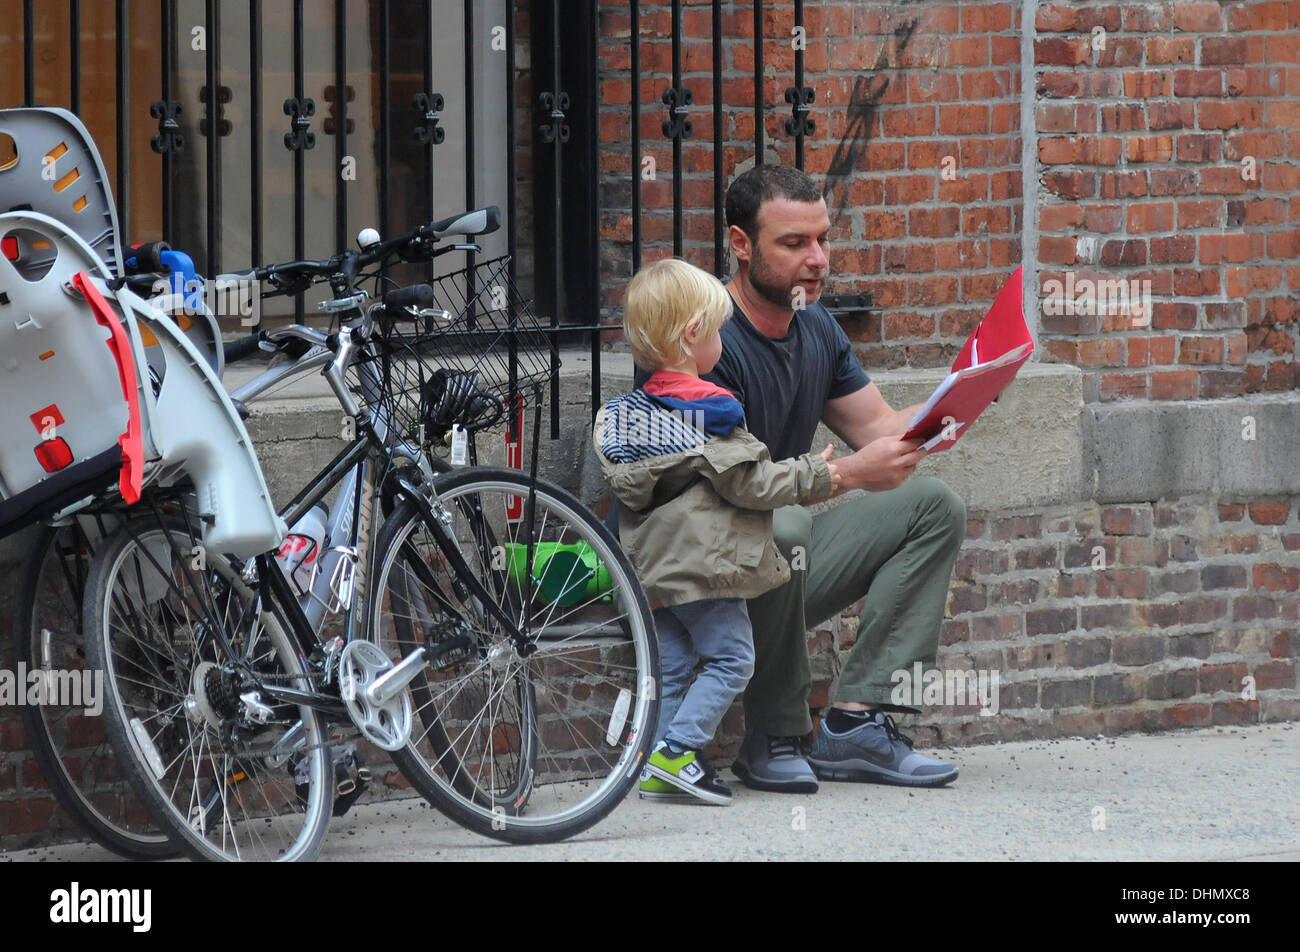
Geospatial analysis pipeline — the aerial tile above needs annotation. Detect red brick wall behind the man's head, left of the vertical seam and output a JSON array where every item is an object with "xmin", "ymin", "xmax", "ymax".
[{"xmin": 599, "ymin": 0, "xmax": 1022, "ymax": 368}]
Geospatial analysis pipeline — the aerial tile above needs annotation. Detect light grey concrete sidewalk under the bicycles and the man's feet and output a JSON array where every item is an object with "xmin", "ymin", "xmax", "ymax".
[{"xmin": 0, "ymin": 723, "xmax": 1300, "ymax": 862}]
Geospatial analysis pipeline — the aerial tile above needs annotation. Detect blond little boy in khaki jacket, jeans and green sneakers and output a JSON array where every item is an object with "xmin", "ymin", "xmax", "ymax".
[{"xmin": 594, "ymin": 259, "xmax": 837, "ymax": 805}]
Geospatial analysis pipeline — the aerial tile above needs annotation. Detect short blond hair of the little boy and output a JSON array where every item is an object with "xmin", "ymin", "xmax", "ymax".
[{"xmin": 623, "ymin": 258, "xmax": 732, "ymax": 371}]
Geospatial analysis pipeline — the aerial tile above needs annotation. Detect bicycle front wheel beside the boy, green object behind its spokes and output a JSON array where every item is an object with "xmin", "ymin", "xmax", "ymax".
[{"xmin": 371, "ymin": 467, "xmax": 659, "ymax": 843}]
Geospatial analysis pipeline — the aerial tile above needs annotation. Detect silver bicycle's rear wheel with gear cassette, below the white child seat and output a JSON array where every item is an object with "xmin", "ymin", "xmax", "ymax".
[{"xmin": 85, "ymin": 520, "xmax": 334, "ymax": 860}]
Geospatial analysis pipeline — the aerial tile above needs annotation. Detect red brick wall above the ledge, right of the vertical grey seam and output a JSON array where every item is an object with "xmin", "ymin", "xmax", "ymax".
[{"xmin": 1035, "ymin": 3, "xmax": 1300, "ymax": 401}]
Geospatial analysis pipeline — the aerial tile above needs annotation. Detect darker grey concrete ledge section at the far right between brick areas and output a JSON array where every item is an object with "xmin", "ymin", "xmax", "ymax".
[{"xmin": 1084, "ymin": 394, "xmax": 1300, "ymax": 502}]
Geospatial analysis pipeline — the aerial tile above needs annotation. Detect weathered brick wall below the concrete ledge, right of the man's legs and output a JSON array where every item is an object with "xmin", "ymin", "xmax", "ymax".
[{"xmin": 810, "ymin": 498, "xmax": 1300, "ymax": 743}]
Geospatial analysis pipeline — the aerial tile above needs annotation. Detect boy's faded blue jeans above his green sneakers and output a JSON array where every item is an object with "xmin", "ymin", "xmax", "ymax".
[{"xmin": 654, "ymin": 598, "xmax": 754, "ymax": 750}]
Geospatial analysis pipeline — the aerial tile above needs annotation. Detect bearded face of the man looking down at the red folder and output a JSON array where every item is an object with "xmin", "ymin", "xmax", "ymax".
[{"xmin": 749, "ymin": 198, "xmax": 831, "ymax": 310}]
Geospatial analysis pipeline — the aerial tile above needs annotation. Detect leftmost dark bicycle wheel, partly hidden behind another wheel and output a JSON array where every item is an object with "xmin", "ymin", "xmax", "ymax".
[{"xmin": 13, "ymin": 523, "xmax": 177, "ymax": 860}]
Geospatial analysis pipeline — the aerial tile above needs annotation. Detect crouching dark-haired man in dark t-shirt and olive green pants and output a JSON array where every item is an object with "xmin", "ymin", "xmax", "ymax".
[{"xmin": 706, "ymin": 165, "xmax": 966, "ymax": 792}]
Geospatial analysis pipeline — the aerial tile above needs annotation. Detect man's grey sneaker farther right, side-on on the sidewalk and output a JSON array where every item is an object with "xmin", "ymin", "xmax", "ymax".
[{"xmin": 809, "ymin": 710, "xmax": 957, "ymax": 787}]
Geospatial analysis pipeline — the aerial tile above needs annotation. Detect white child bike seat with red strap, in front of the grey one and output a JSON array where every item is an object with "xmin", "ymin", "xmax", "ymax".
[{"xmin": 0, "ymin": 212, "xmax": 285, "ymax": 558}]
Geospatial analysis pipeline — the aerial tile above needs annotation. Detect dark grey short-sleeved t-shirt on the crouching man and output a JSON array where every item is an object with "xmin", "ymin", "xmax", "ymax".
[{"xmin": 705, "ymin": 297, "xmax": 871, "ymax": 460}]
